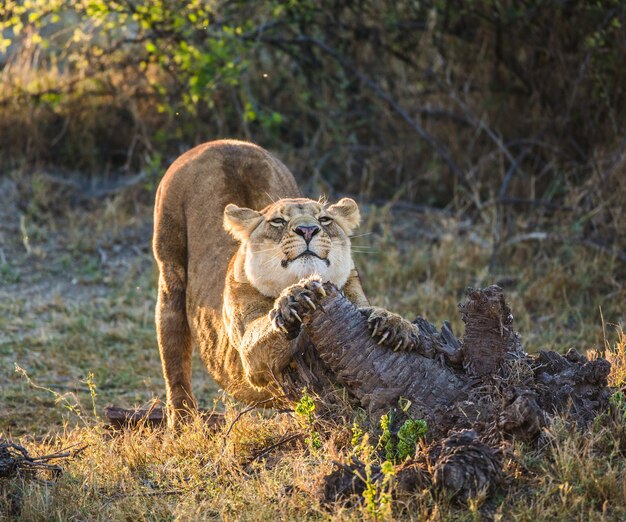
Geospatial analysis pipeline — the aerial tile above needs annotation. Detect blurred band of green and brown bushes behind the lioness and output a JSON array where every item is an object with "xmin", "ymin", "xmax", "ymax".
[{"xmin": 0, "ymin": 0, "xmax": 626, "ymax": 229}]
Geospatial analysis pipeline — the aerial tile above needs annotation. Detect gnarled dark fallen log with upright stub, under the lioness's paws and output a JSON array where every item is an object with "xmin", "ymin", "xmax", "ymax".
[{"xmin": 285, "ymin": 284, "xmax": 610, "ymax": 439}]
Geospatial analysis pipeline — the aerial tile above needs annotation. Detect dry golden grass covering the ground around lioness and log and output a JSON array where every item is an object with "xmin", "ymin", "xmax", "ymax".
[{"xmin": 0, "ymin": 177, "xmax": 626, "ymax": 520}]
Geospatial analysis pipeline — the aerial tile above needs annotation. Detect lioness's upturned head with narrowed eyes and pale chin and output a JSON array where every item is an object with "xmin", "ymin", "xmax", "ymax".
[{"xmin": 224, "ymin": 198, "xmax": 360, "ymax": 297}]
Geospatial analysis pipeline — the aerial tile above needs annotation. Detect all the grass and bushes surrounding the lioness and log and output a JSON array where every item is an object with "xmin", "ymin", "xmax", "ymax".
[{"xmin": 0, "ymin": 0, "xmax": 626, "ymax": 521}]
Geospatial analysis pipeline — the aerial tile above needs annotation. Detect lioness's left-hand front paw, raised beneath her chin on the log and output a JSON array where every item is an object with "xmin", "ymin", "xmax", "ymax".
[{"xmin": 270, "ymin": 277, "xmax": 326, "ymax": 339}]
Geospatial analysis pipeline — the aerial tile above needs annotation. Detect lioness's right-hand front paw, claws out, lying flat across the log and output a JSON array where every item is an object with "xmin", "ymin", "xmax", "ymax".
[{"xmin": 359, "ymin": 306, "xmax": 419, "ymax": 351}]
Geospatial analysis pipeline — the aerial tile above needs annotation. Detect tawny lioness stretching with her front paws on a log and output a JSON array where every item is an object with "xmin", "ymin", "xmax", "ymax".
[{"xmin": 153, "ymin": 140, "xmax": 417, "ymax": 425}]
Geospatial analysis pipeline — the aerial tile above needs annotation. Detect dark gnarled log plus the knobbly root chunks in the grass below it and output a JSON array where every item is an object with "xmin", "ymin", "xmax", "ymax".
[{"xmin": 285, "ymin": 285, "xmax": 611, "ymax": 501}]
